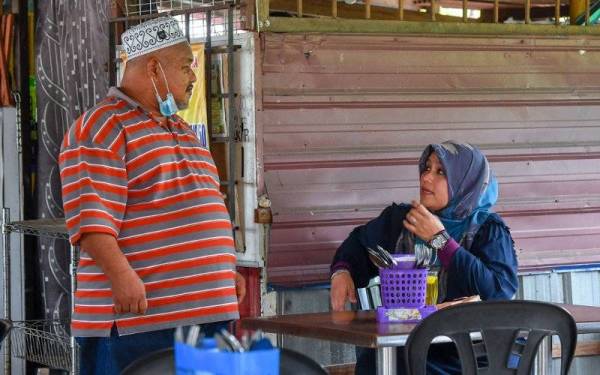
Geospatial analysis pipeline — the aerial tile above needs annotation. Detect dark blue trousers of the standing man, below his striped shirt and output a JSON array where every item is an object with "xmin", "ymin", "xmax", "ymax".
[{"xmin": 76, "ymin": 322, "xmax": 229, "ymax": 375}]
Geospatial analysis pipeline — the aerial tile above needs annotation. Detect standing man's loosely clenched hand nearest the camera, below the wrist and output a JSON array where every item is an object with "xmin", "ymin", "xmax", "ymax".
[{"xmin": 110, "ymin": 267, "xmax": 148, "ymax": 314}]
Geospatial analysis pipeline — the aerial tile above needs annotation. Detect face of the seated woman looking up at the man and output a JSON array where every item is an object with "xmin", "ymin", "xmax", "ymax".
[{"xmin": 420, "ymin": 152, "xmax": 448, "ymax": 211}]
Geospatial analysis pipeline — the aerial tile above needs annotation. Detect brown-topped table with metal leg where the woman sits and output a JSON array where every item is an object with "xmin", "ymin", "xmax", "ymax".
[{"xmin": 242, "ymin": 304, "xmax": 600, "ymax": 375}]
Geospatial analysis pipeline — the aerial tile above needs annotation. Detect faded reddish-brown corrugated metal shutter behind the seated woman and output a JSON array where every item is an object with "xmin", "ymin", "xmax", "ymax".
[{"xmin": 257, "ymin": 34, "xmax": 600, "ymax": 285}]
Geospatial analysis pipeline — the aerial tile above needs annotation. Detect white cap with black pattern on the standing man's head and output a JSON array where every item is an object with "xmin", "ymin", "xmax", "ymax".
[{"xmin": 121, "ymin": 17, "xmax": 187, "ymax": 60}]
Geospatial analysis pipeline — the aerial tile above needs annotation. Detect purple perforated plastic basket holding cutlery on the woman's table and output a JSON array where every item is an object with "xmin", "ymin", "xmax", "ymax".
[{"xmin": 379, "ymin": 262, "xmax": 427, "ymax": 309}]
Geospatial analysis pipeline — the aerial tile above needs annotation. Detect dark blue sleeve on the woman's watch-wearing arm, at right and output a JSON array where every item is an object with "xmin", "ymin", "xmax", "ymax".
[{"xmin": 447, "ymin": 221, "xmax": 519, "ymax": 300}]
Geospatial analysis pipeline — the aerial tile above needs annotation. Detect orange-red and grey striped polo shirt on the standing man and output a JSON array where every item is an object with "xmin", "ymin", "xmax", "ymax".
[{"xmin": 59, "ymin": 88, "xmax": 239, "ymax": 337}]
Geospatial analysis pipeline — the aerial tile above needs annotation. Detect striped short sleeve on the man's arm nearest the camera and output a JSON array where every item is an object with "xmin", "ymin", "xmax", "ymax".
[{"xmin": 59, "ymin": 132, "xmax": 127, "ymax": 245}]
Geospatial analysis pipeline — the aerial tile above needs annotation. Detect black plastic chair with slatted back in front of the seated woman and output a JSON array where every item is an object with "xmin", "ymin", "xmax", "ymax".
[{"xmin": 405, "ymin": 301, "xmax": 577, "ymax": 375}]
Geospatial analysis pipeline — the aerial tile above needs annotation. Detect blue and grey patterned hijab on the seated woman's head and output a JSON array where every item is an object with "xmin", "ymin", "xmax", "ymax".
[{"xmin": 419, "ymin": 141, "xmax": 498, "ymax": 249}]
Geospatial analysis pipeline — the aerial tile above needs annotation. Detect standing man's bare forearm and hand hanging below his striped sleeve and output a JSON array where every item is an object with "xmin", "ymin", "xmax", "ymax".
[{"xmin": 80, "ymin": 233, "xmax": 148, "ymax": 314}]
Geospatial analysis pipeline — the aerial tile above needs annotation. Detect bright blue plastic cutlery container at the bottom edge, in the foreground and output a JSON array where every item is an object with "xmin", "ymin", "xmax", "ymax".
[{"xmin": 175, "ymin": 342, "xmax": 279, "ymax": 375}]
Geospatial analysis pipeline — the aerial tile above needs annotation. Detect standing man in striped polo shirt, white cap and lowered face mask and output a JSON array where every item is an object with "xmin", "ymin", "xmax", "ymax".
[{"xmin": 59, "ymin": 17, "xmax": 245, "ymax": 375}]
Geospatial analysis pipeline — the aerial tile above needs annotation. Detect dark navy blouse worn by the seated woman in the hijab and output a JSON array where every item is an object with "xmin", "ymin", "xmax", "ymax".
[{"xmin": 331, "ymin": 203, "xmax": 519, "ymax": 300}]
